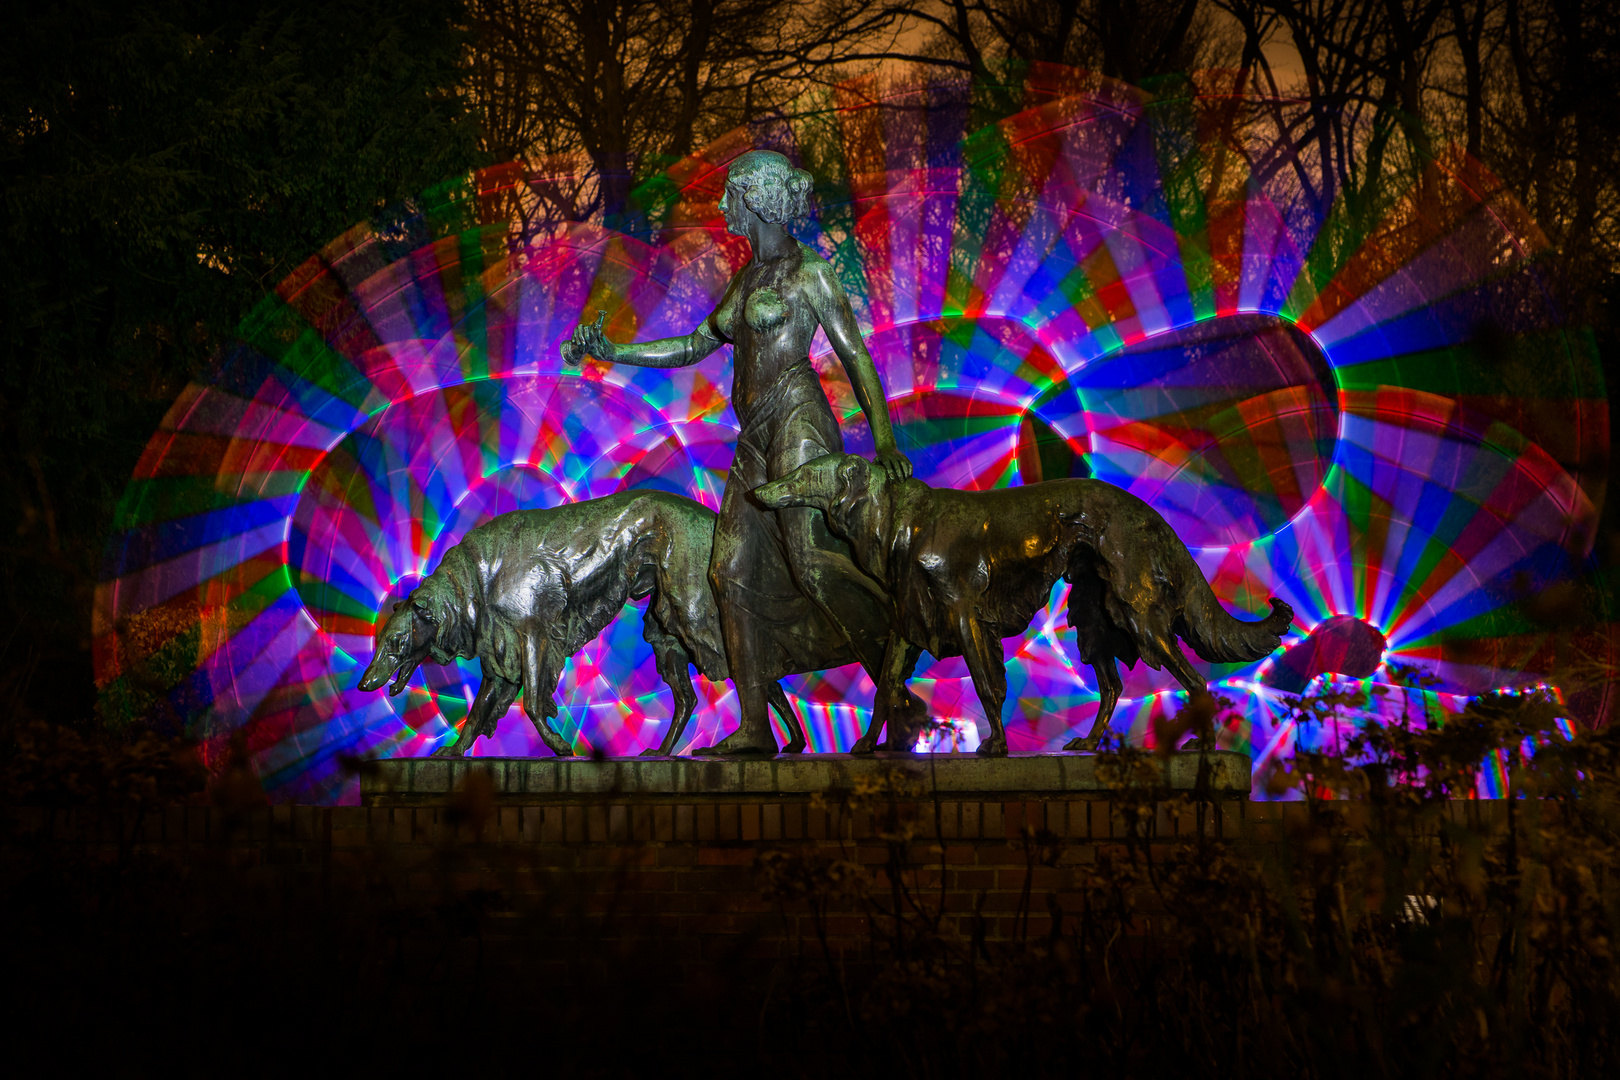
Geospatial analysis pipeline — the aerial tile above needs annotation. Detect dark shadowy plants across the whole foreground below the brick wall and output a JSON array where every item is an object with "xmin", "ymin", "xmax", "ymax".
[{"xmin": 0, "ymin": 696, "xmax": 1620, "ymax": 1077}]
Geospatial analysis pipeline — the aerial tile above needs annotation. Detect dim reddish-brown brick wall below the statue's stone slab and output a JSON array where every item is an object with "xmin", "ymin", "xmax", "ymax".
[{"xmin": 5, "ymin": 798, "xmax": 1276, "ymax": 963}]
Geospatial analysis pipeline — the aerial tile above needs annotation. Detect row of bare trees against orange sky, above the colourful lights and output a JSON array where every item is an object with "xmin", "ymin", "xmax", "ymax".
[{"xmin": 465, "ymin": 0, "xmax": 1620, "ymax": 325}]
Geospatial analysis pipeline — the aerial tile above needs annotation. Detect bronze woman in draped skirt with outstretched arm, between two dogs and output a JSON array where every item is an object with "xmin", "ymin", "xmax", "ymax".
[{"xmin": 562, "ymin": 151, "xmax": 922, "ymax": 755}]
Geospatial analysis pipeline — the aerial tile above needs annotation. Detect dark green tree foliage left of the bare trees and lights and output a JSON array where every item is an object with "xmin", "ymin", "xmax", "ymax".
[{"xmin": 0, "ymin": 0, "xmax": 476, "ymax": 735}]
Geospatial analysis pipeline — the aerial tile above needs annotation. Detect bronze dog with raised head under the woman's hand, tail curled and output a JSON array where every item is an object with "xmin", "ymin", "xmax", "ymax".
[{"xmin": 755, "ymin": 453, "xmax": 1294, "ymax": 755}]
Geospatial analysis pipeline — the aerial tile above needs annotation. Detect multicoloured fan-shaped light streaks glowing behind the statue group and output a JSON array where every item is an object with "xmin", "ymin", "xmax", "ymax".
[{"xmin": 96, "ymin": 70, "xmax": 1609, "ymax": 801}]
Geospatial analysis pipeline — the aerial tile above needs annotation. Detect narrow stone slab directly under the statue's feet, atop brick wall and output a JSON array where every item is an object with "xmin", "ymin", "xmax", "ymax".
[{"xmin": 360, "ymin": 750, "xmax": 1251, "ymax": 806}]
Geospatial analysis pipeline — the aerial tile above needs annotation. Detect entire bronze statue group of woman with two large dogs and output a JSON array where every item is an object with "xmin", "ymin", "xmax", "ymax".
[{"xmin": 361, "ymin": 151, "xmax": 1293, "ymax": 755}]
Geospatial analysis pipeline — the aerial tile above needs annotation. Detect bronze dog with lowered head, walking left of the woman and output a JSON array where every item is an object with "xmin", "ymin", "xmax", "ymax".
[{"xmin": 360, "ymin": 491, "xmax": 805, "ymax": 758}]
